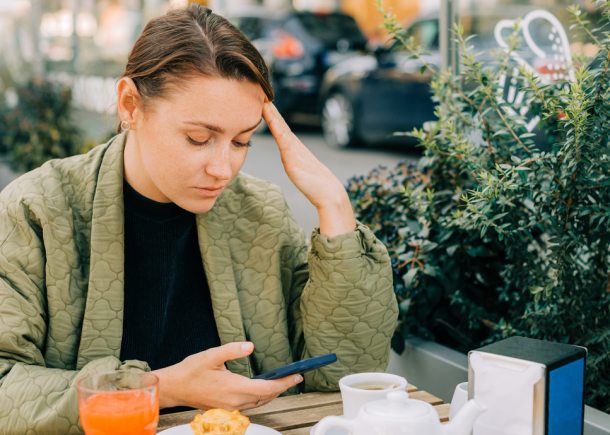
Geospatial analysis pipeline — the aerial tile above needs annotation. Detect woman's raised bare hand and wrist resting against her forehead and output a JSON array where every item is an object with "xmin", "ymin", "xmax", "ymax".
[{"xmin": 263, "ymin": 102, "xmax": 356, "ymax": 237}]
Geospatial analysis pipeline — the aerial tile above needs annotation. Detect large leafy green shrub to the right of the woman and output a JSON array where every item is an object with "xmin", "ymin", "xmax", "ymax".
[{"xmin": 348, "ymin": 3, "xmax": 610, "ymax": 412}]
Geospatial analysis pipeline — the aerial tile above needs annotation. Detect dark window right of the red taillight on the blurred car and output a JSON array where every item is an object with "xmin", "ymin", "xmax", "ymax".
[{"xmin": 297, "ymin": 13, "xmax": 367, "ymax": 49}]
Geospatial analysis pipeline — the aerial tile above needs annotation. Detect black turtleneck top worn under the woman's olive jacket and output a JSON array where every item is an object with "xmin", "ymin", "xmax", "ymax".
[{"xmin": 121, "ymin": 181, "xmax": 220, "ymax": 416}]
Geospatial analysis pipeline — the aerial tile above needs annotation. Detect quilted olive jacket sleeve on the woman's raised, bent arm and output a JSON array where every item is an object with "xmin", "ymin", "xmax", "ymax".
[{"xmin": 290, "ymin": 223, "xmax": 398, "ymax": 392}]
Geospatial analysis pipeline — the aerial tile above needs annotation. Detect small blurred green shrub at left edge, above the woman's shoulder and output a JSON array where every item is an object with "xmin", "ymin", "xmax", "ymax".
[{"xmin": 2, "ymin": 79, "xmax": 83, "ymax": 171}]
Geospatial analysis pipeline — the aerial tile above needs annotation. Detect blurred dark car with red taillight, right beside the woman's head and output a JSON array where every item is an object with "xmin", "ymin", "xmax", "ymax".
[{"xmin": 225, "ymin": 6, "xmax": 367, "ymax": 119}]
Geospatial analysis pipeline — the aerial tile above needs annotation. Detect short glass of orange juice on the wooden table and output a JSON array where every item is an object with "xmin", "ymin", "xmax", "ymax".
[{"xmin": 76, "ymin": 370, "xmax": 159, "ymax": 435}]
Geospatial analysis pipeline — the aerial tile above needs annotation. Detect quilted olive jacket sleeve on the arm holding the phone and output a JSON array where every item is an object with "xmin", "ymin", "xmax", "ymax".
[{"xmin": 0, "ymin": 201, "xmax": 148, "ymax": 435}]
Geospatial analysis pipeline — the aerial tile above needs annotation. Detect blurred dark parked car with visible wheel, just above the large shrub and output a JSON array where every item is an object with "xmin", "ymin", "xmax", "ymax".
[{"xmin": 319, "ymin": 18, "xmax": 440, "ymax": 148}]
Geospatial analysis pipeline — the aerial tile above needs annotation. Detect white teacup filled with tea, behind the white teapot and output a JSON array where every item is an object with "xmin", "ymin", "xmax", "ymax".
[{"xmin": 339, "ymin": 373, "xmax": 407, "ymax": 418}]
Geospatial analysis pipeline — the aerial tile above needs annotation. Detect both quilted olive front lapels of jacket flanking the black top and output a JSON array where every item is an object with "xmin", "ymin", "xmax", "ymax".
[{"xmin": 77, "ymin": 133, "xmax": 252, "ymax": 376}]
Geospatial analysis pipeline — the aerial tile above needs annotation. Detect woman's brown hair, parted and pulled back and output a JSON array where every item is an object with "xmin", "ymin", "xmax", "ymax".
[{"xmin": 118, "ymin": 3, "xmax": 273, "ymax": 133}]
